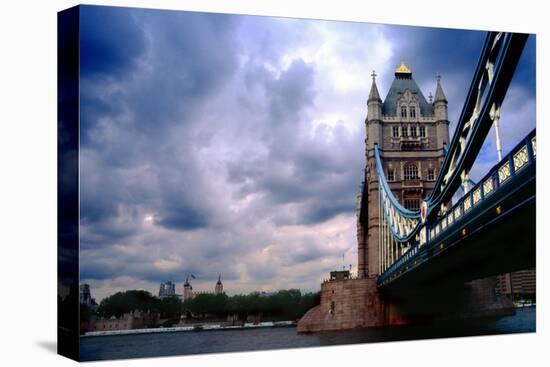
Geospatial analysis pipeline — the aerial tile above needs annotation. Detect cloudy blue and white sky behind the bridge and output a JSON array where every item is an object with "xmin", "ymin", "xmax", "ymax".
[{"xmin": 80, "ymin": 6, "xmax": 536, "ymax": 300}]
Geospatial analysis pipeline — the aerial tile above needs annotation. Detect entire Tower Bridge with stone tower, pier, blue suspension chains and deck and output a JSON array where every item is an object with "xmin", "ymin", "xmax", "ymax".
[{"xmin": 298, "ymin": 32, "xmax": 536, "ymax": 332}]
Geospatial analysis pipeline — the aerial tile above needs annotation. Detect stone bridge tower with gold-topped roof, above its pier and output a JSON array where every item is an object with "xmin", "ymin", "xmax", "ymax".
[{"xmin": 357, "ymin": 63, "xmax": 449, "ymax": 278}]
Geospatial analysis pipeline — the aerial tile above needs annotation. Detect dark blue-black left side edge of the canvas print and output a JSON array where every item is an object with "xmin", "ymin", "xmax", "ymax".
[{"xmin": 57, "ymin": 6, "xmax": 80, "ymax": 360}]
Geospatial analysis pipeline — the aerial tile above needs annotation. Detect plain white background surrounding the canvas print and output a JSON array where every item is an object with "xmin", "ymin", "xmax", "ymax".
[{"xmin": 0, "ymin": 0, "xmax": 550, "ymax": 367}]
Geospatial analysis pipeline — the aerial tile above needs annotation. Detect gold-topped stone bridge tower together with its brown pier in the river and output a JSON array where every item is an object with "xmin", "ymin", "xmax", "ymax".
[{"xmin": 297, "ymin": 63, "xmax": 511, "ymax": 333}]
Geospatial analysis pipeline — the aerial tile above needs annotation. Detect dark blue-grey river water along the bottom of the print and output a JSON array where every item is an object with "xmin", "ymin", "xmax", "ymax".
[{"xmin": 80, "ymin": 307, "xmax": 536, "ymax": 361}]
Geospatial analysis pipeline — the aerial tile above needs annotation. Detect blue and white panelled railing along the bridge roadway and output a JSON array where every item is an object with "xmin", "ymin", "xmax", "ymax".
[{"xmin": 378, "ymin": 129, "xmax": 537, "ymax": 284}]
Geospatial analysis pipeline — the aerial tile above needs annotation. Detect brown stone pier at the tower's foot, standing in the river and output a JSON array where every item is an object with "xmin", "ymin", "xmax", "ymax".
[{"xmin": 298, "ymin": 277, "xmax": 514, "ymax": 333}]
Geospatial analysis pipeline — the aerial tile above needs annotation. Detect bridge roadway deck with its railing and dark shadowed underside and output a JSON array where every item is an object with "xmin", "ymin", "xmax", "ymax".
[{"xmin": 378, "ymin": 130, "xmax": 536, "ymax": 298}]
